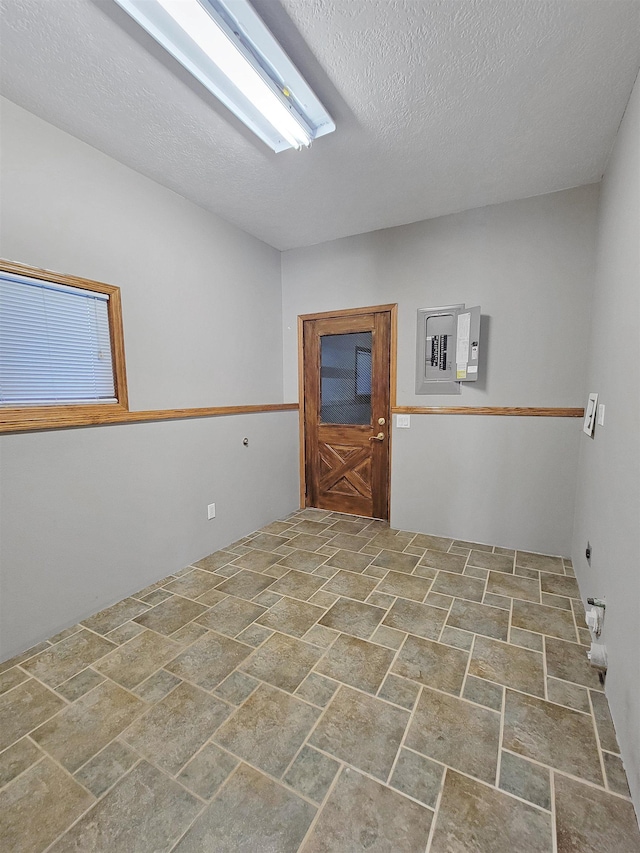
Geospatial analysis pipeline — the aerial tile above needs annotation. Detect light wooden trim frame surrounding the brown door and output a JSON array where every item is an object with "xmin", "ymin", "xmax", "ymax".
[{"xmin": 298, "ymin": 302, "xmax": 398, "ymax": 510}]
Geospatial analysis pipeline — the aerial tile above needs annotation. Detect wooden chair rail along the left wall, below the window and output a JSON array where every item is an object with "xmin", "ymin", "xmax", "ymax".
[{"xmin": 0, "ymin": 403, "xmax": 298, "ymax": 433}]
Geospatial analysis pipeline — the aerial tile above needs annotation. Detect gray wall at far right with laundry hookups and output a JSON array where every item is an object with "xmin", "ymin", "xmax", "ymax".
[{"xmin": 573, "ymin": 73, "xmax": 640, "ymax": 815}]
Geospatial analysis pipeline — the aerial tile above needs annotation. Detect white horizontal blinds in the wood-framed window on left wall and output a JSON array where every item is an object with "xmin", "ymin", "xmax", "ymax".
[{"xmin": 0, "ymin": 272, "xmax": 117, "ymax": 406}]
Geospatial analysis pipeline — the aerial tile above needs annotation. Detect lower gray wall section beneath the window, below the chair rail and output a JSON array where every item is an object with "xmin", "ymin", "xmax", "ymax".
[{"xmin": 0, "ymin": 412, "xmax": 298, "ymax": 660}]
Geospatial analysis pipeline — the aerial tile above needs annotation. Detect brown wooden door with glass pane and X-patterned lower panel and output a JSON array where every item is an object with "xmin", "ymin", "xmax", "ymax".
[{"xmin": 301, "ymin": 306, "xmax": 392, "ymax": 519}]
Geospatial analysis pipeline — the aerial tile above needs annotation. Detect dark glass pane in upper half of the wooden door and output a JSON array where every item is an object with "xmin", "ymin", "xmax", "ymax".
[{"xmin": 320, "ymin": 332, "xmax": 371, "ymax": 424}]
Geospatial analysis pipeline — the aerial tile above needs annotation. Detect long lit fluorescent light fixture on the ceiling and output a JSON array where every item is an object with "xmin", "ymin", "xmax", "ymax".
[{"xmin": 115, "ymin": 0, "xmax": 336, "ymax": 151}]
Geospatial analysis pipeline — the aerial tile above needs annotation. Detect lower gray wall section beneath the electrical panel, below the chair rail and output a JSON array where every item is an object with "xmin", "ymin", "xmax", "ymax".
[{"xmin": 391, "ymin": 420, "xmax": 582, "ymax": 555}]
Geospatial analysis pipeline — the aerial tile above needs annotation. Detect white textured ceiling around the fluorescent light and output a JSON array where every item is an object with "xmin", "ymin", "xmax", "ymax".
[{"xmin": 0, "ymin": 0, "xmax": 640, "ymax": 249}]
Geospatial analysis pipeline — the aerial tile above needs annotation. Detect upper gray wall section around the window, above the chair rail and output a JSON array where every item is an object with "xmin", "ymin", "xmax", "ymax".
[{"xmin": 0, "ymin": 100, "xmax": 282, "ymax": 409}]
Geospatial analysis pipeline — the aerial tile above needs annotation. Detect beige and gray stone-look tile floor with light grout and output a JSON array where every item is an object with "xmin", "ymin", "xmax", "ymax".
[{"xmin": 0, "ymin": 510, "xmax": 640, "ymax": 853}]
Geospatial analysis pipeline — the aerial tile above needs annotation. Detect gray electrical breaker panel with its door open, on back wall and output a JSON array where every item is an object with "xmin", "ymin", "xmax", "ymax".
[{"xmin": 416, "ymin": 304, "xmax": 480, "ymax": 394}]
